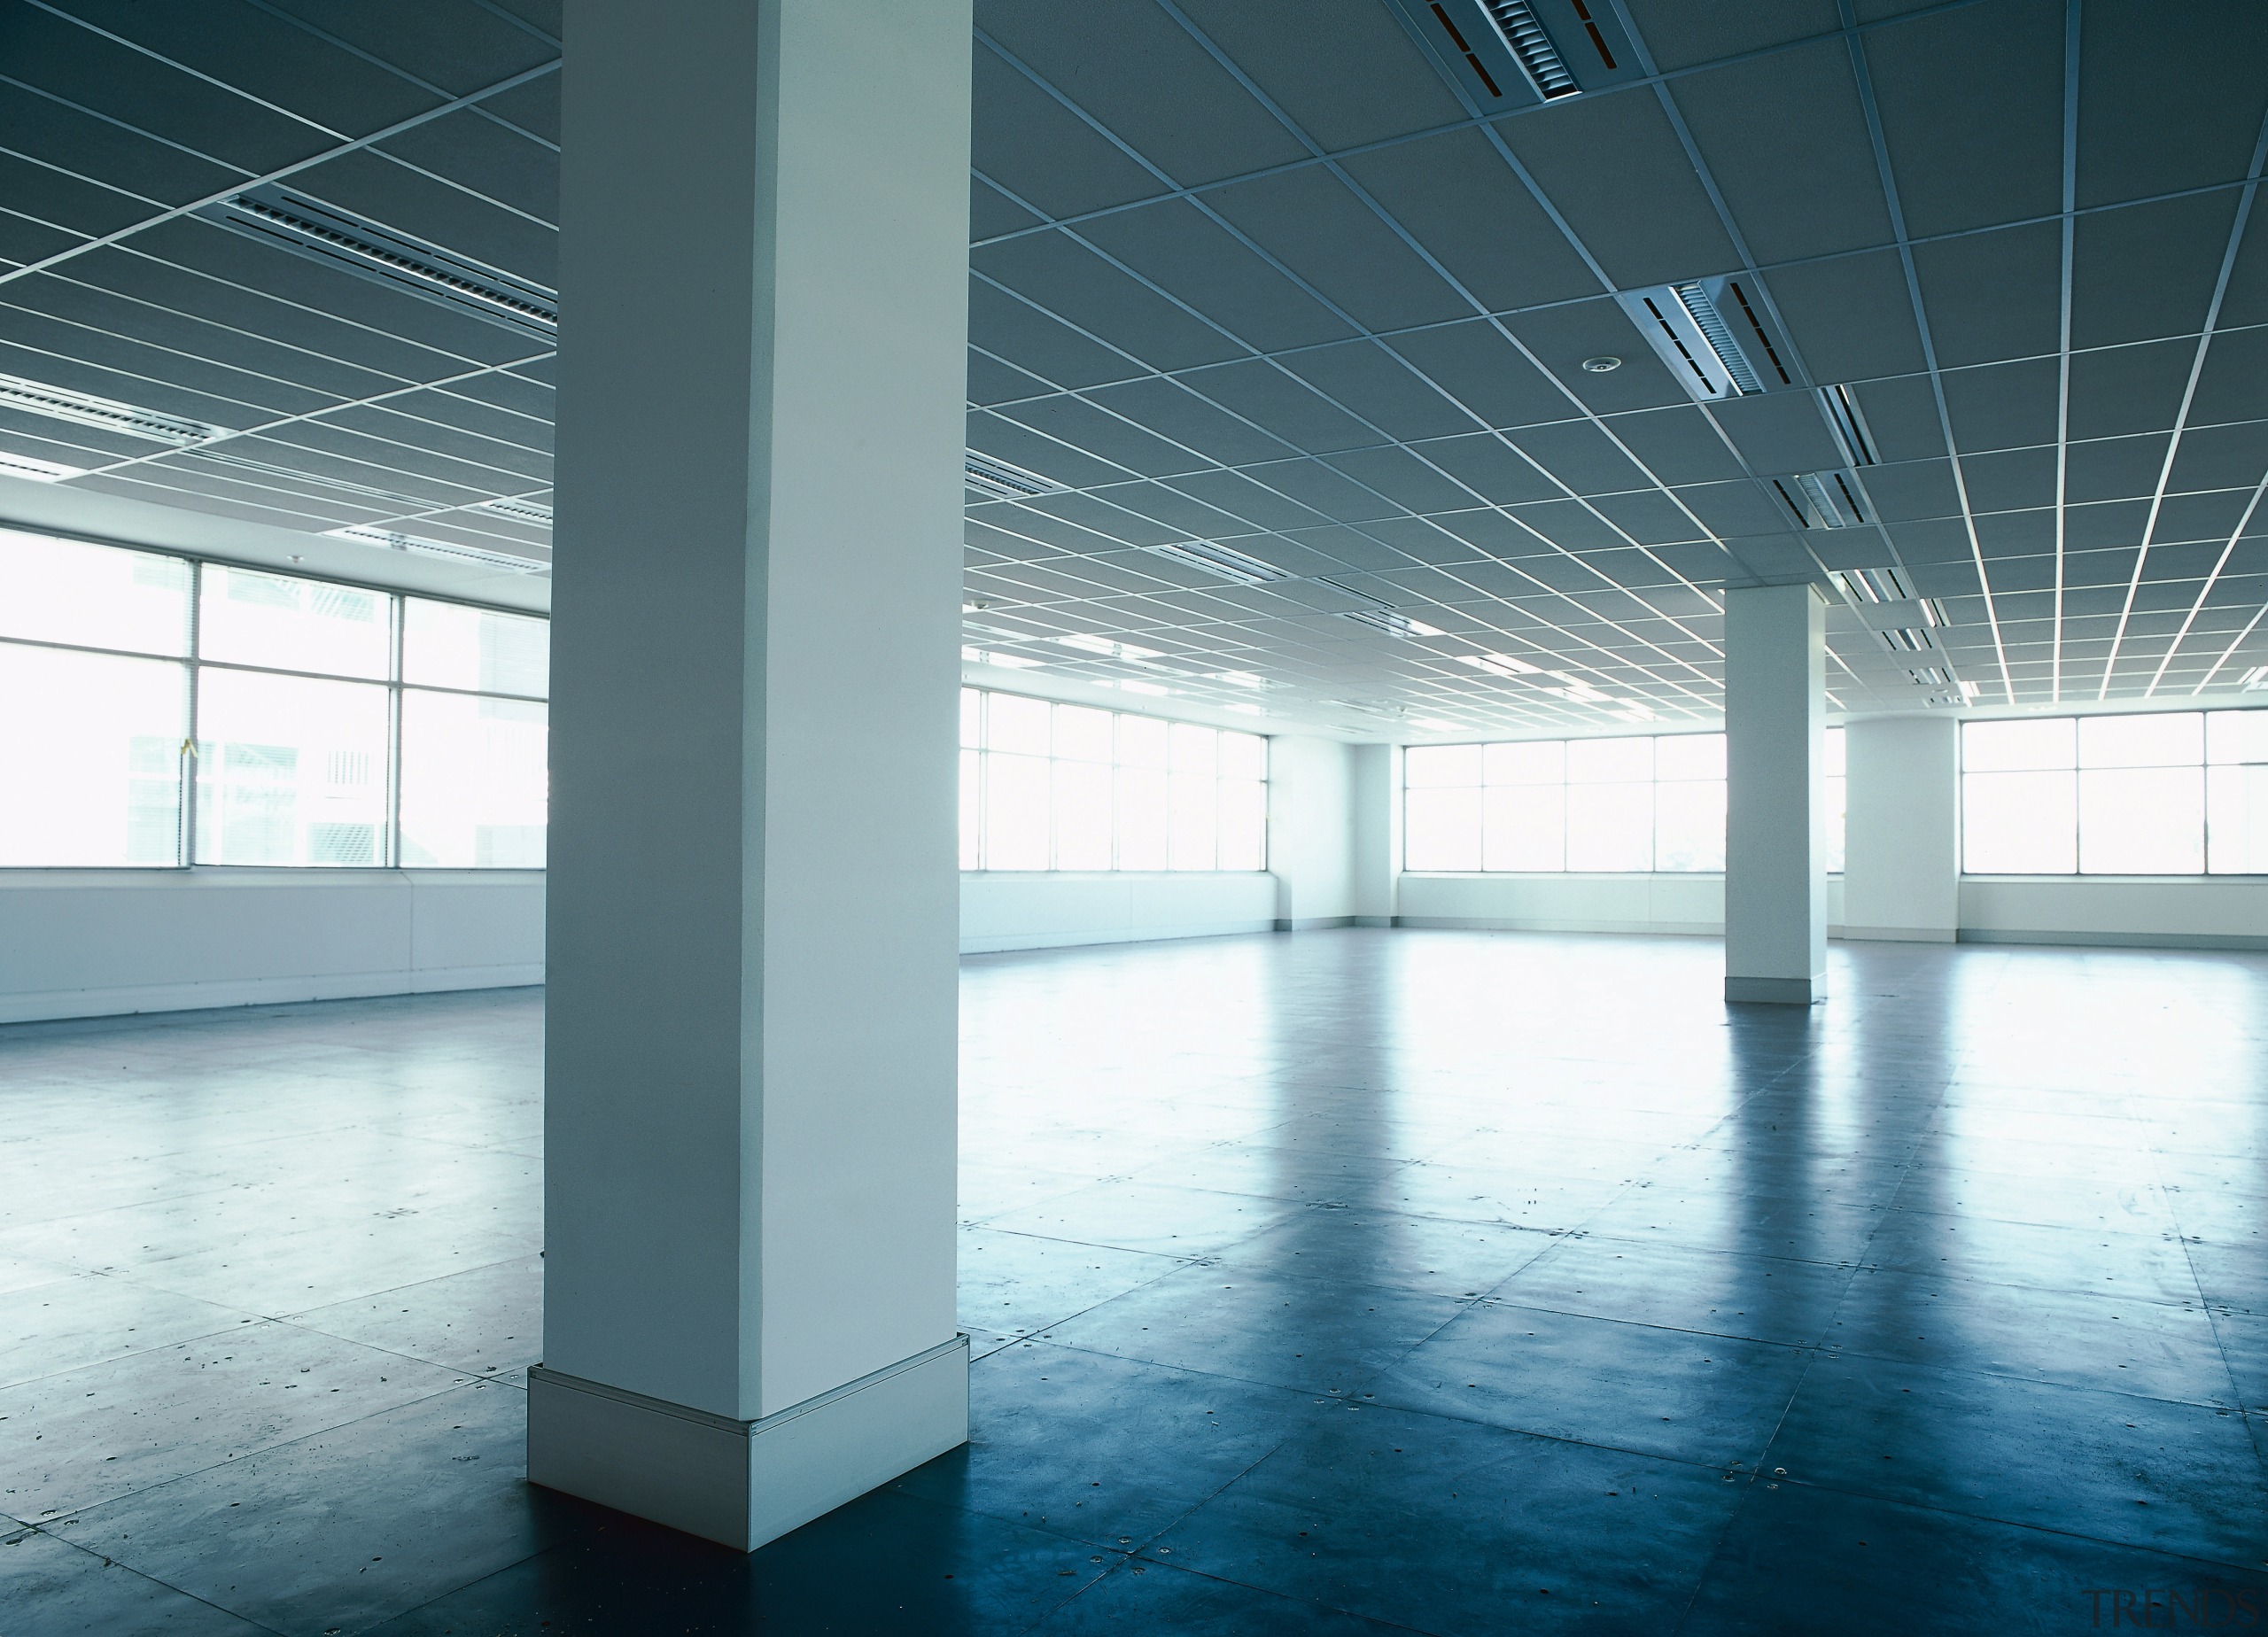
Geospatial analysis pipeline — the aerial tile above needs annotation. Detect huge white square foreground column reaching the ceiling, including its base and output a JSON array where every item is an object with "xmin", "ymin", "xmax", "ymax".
[{"xmin": 528, "ymin": 0, "xmax": 971, "ymax": 1548}]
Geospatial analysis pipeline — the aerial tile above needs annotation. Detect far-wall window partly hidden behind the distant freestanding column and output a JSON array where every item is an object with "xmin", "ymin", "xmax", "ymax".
[{"xmin": 1402, "ymin": 728, "xmax": 1844, "ymax": 875}]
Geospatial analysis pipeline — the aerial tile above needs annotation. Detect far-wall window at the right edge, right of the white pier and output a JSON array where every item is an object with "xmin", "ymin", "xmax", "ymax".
[{"xmin": 1961, "ymin": 710, "xmax": 2268, "ymax": 875}]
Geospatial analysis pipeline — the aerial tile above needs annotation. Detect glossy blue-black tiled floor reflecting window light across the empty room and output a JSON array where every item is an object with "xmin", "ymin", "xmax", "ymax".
[{"xmin": 0, "ymin": 932, "xmax": 2268, "ymax": 1637}]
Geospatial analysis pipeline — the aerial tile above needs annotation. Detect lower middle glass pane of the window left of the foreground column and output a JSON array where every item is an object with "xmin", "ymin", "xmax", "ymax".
[{"xmin": 198, "ymin": 667, "xmax": 388, "ymax": 866}]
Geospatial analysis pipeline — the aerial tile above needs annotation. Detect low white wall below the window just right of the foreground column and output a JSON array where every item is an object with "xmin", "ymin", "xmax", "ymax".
[{"xmin": 961, "ymin": 871, "xmax": 1279, "ymax": 955}]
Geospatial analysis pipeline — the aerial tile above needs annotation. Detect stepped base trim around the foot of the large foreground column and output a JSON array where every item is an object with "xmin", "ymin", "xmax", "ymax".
[{"xmin": 528, "ymin": 1336, "xmax": 968, "ymax": 1551}]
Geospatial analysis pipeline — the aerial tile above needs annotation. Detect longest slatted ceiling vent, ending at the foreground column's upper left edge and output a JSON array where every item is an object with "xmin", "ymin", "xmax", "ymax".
[{"xmin": 199, "ymin": 183, "xmax": 560, "ymax": 340}]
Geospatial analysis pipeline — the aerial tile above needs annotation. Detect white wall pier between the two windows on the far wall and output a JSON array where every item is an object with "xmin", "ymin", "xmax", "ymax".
[{"xmin": 1844, "ymin": 717, "xmax": 1961, "ymax": 943}]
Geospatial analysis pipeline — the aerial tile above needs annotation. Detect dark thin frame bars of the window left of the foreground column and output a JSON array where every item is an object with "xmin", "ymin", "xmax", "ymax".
[{"xmin": 0, "ymin": 524, "xmax": 551, "ymax": 875}]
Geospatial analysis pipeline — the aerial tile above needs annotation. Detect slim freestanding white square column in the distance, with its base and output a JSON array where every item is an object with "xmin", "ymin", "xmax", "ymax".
[{"xmin": 1724, "ymin": 585, "xmax": 1828, "ymax": 1006}]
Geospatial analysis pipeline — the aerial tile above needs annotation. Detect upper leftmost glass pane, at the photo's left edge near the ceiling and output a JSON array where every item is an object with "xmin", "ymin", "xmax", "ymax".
[{"xmin": 0, "ymin": 528, "xmax": 188, "ymax": 648}]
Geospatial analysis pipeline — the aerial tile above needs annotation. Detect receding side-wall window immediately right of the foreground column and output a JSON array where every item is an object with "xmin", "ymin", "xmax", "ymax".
[{"xmin": 961, "ymin": 687, "xmax": 1268, "ymax": 871}]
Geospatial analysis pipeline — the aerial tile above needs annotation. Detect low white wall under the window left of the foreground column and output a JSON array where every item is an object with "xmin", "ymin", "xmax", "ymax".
[{"xmin": 0, "ymin": 868, "xmax": 544, "ymax": 1022}]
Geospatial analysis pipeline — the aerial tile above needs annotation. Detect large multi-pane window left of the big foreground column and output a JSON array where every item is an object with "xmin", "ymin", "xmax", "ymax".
[{"xmin": 0, "ymin": 528, "xmax": 549, "ymax": 868}]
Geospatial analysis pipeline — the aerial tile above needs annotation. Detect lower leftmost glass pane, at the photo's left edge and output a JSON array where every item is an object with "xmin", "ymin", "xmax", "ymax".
[{"xmin": 0, "ymin": 644, "xmax": 188, "ymax": 861}]
